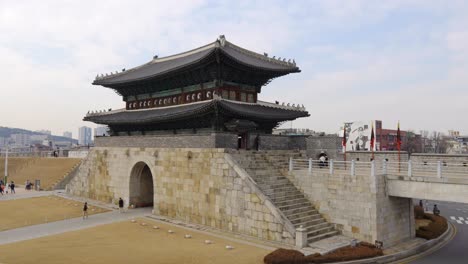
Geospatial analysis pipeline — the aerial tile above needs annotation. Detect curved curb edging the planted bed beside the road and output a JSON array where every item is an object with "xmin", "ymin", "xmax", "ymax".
[{"xmin": 333, "ymin": 221, "xmax": 454, "ymax": 264}]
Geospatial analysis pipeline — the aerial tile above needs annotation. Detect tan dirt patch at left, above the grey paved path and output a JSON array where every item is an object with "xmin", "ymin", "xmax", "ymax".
[{"xmin": 0, "ymin": 194, "xmax": 107, "ymax": 230}]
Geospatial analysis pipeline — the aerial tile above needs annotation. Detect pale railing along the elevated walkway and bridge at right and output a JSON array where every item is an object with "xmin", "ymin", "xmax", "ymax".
[{"xmin": 283, "ymin": 157, "xmax": 468, "ymax": 178}]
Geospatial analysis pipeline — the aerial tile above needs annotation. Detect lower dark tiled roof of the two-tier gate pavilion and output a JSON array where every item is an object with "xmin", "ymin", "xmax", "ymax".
[{"xmin": 83, "ymin": 99, "xmax": 309, "ymax": 125}]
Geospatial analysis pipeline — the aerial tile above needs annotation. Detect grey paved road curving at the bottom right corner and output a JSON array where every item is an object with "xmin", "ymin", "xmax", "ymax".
[{"xmin": 410, "ymin": 201, "xmax": 468, "ymax": 264}]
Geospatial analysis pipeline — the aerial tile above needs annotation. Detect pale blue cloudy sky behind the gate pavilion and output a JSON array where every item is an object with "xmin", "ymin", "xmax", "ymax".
[{"xmin": 0, "ymin": 0, "xmax": 468, "ymax": 138}]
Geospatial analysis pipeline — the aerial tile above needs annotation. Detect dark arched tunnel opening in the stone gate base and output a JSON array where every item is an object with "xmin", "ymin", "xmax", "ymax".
[{"xmin": 129, "ymin": 162, "xmax": 154, "ymax": 207}]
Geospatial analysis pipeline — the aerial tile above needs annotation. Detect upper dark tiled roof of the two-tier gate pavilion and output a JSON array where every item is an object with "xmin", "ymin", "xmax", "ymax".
[{"xmin": 93, "ymin": 36, "xmax": 300, "ymax": 85}]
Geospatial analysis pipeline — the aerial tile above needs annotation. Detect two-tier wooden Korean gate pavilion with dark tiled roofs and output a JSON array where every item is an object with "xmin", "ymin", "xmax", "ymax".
[{"xmin": 84, "ymin": 36, "xmax": 309, "ymax": 148}]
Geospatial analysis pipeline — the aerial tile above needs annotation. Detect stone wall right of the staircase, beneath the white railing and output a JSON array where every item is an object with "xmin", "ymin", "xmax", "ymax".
[{"xmin": 289, "ymin": 169, "xmax": 415, "ymax": 247}]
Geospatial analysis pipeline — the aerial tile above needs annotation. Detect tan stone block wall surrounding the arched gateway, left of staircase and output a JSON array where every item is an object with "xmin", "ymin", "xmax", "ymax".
[{"xmin": 66, "ymin": 147, "xmax": 294, "ymax": 245}]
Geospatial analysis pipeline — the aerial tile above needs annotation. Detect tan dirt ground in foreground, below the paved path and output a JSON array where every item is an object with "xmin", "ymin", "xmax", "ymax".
[{"xmin": 0, "ymin": 219, "xmax": 270, "ymax": 264}]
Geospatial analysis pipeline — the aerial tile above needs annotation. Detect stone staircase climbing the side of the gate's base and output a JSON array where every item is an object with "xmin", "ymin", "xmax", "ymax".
[{"xmin": 232, "ymin": 152, "xmax": 339, "ymax": 243}]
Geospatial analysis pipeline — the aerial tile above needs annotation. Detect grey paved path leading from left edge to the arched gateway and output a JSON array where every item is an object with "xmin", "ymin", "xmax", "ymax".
[{"xmin": 0, "ymin": 208, "xmax": 151, "ymax": 245}]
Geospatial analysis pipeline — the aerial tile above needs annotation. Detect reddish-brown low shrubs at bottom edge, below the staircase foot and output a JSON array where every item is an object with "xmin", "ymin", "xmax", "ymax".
[{"xmin": 264, "ymin": 242, "xmax": 383, "ymax": 264}]
